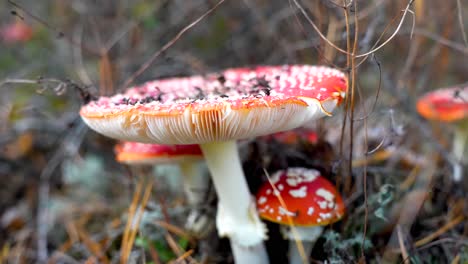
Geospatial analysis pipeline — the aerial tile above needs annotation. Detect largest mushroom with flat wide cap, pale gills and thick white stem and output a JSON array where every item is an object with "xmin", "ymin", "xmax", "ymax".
[{"xmin": 80, "ymin": 65, "xmax": 347, "ymax": 263}]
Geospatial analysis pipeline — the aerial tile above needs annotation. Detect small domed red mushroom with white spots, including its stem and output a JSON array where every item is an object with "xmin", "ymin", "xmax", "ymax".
[{"xmin": 257, "ymin": 168, "xmax": 345, "ymax": 264}]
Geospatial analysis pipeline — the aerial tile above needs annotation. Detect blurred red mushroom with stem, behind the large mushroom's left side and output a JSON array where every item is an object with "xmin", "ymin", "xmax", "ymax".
[{"xmin": 114, "ymin": 141, "xmax": 212, "ymax": 236}]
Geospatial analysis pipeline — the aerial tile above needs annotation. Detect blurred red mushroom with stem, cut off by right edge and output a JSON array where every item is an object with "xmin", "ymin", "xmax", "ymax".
[{"xmin": 416, "ymin": 87, "xmax": 468, "ymax": 182}]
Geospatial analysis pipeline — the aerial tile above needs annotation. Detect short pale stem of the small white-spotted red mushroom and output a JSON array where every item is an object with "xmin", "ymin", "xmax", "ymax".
[{"xmin": 281, "ymin": 226, "xmax": 323, "ymax": 264}]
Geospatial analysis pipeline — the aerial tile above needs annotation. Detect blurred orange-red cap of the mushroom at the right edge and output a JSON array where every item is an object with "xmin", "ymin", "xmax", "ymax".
[{"xmin": 416, "ymin": 87, "xmax": 468, "ymax": 122}]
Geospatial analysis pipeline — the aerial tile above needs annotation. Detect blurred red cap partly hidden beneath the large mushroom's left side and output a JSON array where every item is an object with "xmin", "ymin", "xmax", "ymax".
[{"xmin": 114, "ymin": 142, "xmax": 203, "ymax": 164}]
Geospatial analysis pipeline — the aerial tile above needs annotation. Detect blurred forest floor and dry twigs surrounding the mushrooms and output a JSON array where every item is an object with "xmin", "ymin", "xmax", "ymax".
[{"xmin": 0, "ymin": 0, "xmax": 468, "ymax": 263}]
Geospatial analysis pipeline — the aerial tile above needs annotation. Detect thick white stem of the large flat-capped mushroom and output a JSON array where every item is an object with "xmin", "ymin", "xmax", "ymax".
[{"xmin": 200, "ymin": 141, "xmax": 268, "ymax": 264}]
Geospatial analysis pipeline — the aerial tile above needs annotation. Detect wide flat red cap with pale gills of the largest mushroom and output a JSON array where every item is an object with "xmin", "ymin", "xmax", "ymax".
[{"xmin": 80, "ymin": 65, "xmax": 347, "ymax": 144}]
